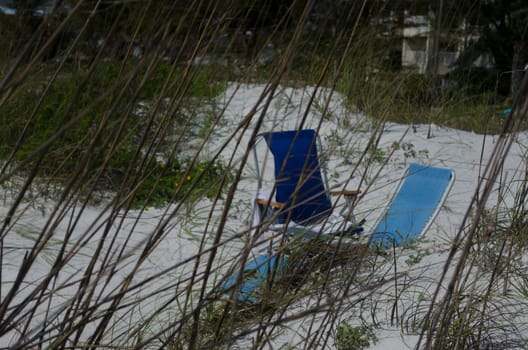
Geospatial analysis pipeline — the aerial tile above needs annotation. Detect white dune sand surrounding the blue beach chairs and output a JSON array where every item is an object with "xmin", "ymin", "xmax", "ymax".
[{"xmin": 0, "ymin": 84, "xmax": 528, "ymax": 350}]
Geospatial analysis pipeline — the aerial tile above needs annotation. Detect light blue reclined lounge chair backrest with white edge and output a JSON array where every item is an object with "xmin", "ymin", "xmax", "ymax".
[{"xmin": 371, "ymin": 164, "xmax": 455, "ymax": 248}]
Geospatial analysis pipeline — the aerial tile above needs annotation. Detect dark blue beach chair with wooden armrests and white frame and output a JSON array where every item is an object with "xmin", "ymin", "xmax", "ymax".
[{"xmin": 256, "ymin": 129, "xmax": 363, "ymax": 239}]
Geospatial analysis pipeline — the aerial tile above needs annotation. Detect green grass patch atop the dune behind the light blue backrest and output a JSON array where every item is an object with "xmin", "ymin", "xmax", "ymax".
[{"xmin": 338, "ymin": 65, "xmax": 511, "ymax": 134}]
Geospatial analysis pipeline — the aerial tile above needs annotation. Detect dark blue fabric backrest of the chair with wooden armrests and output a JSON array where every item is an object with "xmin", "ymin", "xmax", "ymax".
[{"xmin": 261, "ymin": 129, "xmax": 332, "ymax": 224}]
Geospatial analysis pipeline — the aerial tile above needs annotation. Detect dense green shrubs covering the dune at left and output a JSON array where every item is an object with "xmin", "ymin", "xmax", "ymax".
[{"xmin": 0, "ymin": 62, "xmax": 230, "ymax": 206}]
